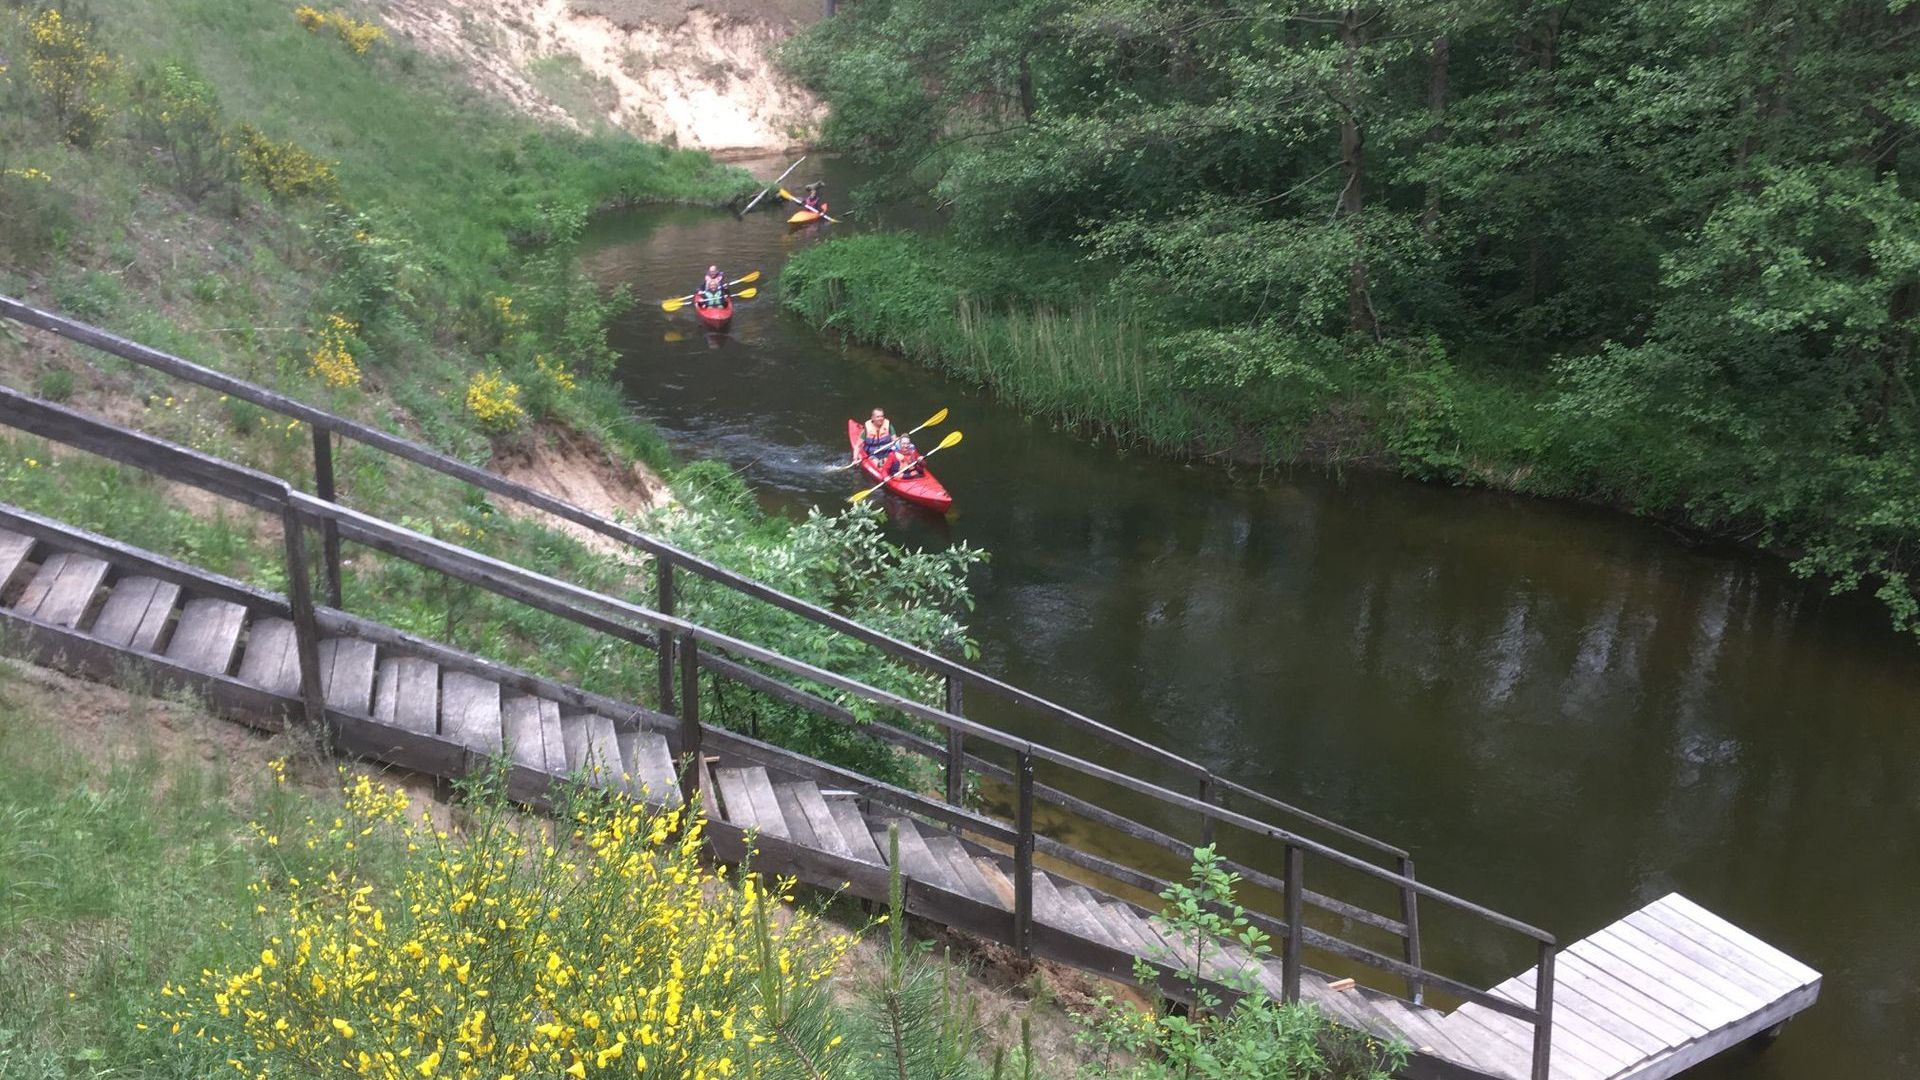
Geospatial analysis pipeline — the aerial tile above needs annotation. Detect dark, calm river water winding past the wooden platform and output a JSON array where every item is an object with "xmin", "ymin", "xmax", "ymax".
[{"xmin": 588, "ymin": 161, "xmax": 1920, "ymax": 1080}]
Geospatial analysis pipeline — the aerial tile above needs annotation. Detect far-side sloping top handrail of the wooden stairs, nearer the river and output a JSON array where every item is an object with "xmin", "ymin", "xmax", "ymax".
[{"xmin": 0, "ymin": 296, "xmax": 1405, "ymax": 859}]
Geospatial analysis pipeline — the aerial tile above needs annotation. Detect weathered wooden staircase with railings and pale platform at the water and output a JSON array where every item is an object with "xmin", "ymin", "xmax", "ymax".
[{"xmin": 0, "ymin": 290, "xmax": 1820, "ymax": 1080}]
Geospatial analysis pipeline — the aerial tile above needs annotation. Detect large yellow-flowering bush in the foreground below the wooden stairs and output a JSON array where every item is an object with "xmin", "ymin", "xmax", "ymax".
[{"xmin": 156, "ymin": 776, "xmax": 852, "ymax": 1080}]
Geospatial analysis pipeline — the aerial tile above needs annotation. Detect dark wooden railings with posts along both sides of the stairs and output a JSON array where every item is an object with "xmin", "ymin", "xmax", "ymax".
[{"xmin": 0, "ymin": 296, "xmax": 1553, "ymax": 1080}]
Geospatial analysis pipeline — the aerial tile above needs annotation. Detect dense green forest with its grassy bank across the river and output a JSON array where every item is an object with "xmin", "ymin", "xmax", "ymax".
[{"xmin": 787, "ymin": 0, "xmax": 1920, "ymax": 628}]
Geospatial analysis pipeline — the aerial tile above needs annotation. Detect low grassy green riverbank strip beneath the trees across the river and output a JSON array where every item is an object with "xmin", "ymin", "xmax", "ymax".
[{"xmin": 781, "ymin": 233, "xmax": 1920, "ymax": 628}]
